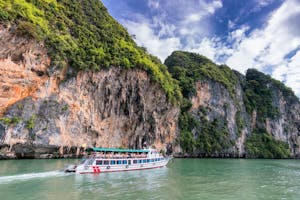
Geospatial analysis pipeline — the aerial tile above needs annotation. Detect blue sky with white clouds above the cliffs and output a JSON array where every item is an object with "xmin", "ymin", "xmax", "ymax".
[{"xmin": 102, "ymin": 0, "xmax": 300, "ymax": 97}]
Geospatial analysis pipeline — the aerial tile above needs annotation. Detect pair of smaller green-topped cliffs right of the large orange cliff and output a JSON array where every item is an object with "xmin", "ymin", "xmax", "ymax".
[{"xmin": 165, "ymin": 51, "xmax": 300, "ymax": 158}]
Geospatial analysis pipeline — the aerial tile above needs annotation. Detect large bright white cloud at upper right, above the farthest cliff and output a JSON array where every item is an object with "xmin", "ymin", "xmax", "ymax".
[{"xmin": 226, "ymin": 0, "xmax": 300, "ymax": 79}]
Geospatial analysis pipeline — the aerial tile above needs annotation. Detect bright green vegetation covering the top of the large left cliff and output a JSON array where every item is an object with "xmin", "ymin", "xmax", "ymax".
[{"xmin": 0, "ymin": 0, "xmax": 181, "ymax": 101}]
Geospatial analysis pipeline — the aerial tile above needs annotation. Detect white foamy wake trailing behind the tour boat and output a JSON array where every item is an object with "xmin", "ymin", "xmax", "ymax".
[{"xmin": 0, "ymin": 170, "xmax": 67, "ymax": 184}]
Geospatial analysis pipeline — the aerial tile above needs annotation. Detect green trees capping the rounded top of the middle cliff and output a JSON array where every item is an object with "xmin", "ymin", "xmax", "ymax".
[{"xmin": 165, "ymin": 51, "xmax": 238, "ymax": 97}]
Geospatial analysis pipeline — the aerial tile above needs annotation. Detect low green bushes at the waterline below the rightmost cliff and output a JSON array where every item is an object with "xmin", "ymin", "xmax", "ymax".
[{"xmin": 245, "ymin": 130, "xmax": 290, "ymax": 158}]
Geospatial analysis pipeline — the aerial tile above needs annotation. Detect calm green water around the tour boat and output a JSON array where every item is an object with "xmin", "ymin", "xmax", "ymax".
[{"xmin": 0, "ymin": 159, "xmax": 300, "ymax": 200}]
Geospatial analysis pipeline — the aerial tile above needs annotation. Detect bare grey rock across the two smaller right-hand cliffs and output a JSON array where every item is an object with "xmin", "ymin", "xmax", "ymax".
[{"xmin": 189, "ymin": 76, "xmax": 300, "ymax": 157}]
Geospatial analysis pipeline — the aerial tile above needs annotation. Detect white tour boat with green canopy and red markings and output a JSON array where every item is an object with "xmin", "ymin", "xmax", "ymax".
[{"xmin": 65, "ymin": 148, "xmax": 171, "ymax": 174}]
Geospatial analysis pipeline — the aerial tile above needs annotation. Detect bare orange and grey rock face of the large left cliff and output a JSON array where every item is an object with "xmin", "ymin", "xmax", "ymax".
[{"xmin": 0, "ymin": 26, "xmax": 179, "ymax": 158}]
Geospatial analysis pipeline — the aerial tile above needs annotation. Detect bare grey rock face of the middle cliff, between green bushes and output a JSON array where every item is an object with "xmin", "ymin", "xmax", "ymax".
[{"xmin": 189, "ymin": 79, "xmax": 252, "ymax": 157}]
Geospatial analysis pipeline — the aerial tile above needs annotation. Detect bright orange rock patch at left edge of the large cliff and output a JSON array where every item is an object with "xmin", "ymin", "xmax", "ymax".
[{"xmin": 0, "ymin": 24, "xmax": 50, "ymax": 116}]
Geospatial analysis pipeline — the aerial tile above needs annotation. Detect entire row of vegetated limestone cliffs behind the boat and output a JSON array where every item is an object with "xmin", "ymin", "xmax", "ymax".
[{"xmin": 0, "ymin": 0, "xmax": 300, "ymax": 159}]
